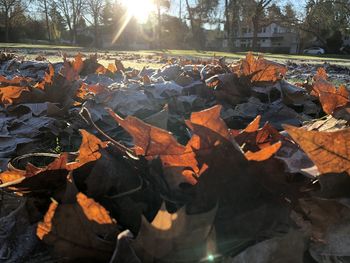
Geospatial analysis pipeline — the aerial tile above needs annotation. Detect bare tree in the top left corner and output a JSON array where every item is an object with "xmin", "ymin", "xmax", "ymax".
[{"xmin": 0, "ymin": 0, "xmax": 29, "ymax": 42}]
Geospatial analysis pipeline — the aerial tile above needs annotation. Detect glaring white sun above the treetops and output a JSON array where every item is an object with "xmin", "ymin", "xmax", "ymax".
[{"xmin": 122, "ymin": 0, "xmax": 154, "ymax": 23}]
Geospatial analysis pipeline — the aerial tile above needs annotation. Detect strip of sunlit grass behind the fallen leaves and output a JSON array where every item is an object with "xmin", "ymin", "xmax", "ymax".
[{"xmin": 0, "ymin": 43, "xmax": 350, "ymax": 68}]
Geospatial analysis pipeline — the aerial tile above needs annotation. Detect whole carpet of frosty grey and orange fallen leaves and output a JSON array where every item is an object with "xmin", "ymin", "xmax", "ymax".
[{"xmin": 0, "ymin": 53, "xmax": 350, "ymax": 263}]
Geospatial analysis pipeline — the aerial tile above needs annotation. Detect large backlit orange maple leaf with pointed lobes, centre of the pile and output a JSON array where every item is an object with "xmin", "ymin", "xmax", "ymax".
[{"xmin": 109, "ymin": 106, "xmax": 234, "ymax": 184}]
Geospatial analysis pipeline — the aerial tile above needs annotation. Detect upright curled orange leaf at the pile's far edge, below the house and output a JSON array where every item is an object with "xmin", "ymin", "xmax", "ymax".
[{"xmin": 233, "ymin": 52, "xmax": 287, "ymax": 82}]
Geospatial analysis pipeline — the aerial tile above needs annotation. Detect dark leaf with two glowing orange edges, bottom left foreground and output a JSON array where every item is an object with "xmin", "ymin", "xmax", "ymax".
[{"xmin": 36, "ymin": 186, "xmax": 119, "ymax": 261}]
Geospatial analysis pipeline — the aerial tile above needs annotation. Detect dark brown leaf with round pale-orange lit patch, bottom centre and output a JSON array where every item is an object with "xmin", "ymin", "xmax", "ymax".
[{"xmin": 135, "ymin": 205, "xmax": 217, "ymax": 262}]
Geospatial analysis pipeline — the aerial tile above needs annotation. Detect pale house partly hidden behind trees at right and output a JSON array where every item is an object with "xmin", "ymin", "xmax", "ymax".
[{"xmin": 232, "ymin": 23, "xmax": 299, "ymax": 54}]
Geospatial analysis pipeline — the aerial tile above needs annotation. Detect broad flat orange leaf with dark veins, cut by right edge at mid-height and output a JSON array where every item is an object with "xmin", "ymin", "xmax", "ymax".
[{"xmin": 284, "ymin": 125, "xmax": 350, "ymax": 175}]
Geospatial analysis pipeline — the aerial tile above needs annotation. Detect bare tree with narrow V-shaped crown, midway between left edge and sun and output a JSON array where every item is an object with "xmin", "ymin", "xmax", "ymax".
[{"xmin": 56, "ymin": 0, "xmax": 84, "ymax": 44}]
